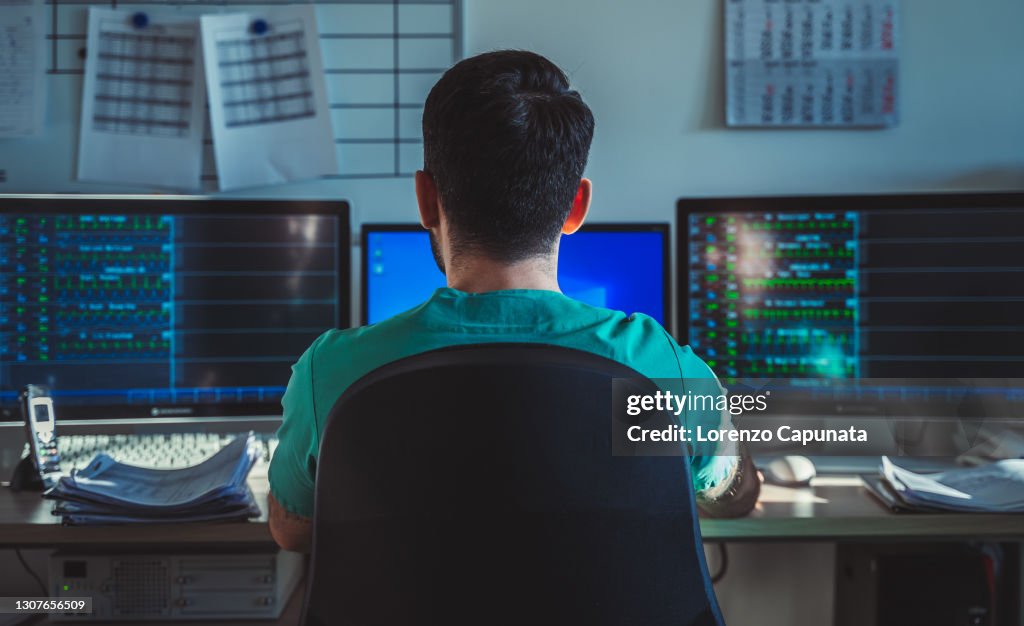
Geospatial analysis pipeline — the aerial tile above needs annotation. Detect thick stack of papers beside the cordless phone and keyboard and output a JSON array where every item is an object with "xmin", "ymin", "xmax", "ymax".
[{"xmin": 44, "ymin": 435, "xmax": 260, "ymax": 526}]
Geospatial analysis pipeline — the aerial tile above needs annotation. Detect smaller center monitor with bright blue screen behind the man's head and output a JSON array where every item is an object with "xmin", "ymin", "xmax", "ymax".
[{"xmin": 362, "ymin": 223, "xmax": 670, "ymax": 325}]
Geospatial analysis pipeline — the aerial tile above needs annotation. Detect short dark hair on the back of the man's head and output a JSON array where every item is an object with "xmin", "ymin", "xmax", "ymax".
[{"xmin": 423, "ymin": 50, "xmax": 594, "ymax": 262}]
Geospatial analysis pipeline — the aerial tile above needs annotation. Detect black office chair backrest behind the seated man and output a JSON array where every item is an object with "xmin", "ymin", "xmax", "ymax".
[{"xmin": 303, "ymin": 344, "xmax": 722, "ymax": 626}]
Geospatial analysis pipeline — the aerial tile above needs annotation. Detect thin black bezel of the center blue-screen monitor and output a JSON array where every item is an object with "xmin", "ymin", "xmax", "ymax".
[{"xmin": 359, "ymin": 221, "xmax": 673, "ymax": 334}]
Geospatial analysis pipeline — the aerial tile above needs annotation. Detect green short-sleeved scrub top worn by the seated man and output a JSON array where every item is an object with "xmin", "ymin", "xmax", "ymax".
[{"xmin": 269, "ymin": 288, "xmax": 735, "ymax": 517}]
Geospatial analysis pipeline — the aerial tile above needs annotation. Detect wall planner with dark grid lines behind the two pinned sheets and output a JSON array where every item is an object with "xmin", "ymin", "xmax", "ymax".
[{"xmin": 44, "ymin": 0, "xmax": 463, "ymax": 186}]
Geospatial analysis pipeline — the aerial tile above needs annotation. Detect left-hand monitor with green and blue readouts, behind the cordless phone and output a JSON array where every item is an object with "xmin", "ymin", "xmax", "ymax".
[{"xmin": 0, "ymin": 196, "xmax": 350, "ymax": 420}]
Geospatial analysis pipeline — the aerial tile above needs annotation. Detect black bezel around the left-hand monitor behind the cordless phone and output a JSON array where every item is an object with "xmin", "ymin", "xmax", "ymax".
[{"xmin": 0, "ymin": 195, "xmax": 352, "ymax": 422}]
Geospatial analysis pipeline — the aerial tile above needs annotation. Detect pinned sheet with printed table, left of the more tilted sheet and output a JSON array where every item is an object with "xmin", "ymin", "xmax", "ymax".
[{"xmin": 78, "ymin": 8, "xmax": 206, "ymax": 190}]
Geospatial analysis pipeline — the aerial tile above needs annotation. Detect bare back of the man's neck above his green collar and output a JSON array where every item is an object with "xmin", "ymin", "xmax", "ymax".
[{"xmin": 445, "ymin": 256, "xmax": 561, "ymax": 293}]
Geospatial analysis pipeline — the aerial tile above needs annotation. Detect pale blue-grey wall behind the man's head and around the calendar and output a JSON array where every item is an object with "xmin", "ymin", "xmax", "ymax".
[{"xmin": 0, "ymin": 0, "xmax": 1024, "ymax": 213}]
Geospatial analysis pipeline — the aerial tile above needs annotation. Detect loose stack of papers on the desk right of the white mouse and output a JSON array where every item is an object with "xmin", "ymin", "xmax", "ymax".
[{"xmin": 871, "ymin": 457, "xmax": 1024, "ymax": 513}]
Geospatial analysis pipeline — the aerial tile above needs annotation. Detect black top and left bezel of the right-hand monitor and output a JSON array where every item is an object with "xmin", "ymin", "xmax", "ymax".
[{"xmin": 675, "ymin": 191, "xmax": 1024, "ymax": 345}]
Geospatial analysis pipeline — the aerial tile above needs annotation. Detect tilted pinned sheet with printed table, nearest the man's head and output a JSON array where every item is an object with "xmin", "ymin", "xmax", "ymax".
[{"xmin": 201, "ymin": 6, "xmax": 338, "ymax": 190}]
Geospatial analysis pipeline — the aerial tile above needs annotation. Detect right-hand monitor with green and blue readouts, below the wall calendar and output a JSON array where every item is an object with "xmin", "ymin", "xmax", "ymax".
[{"xmin": 677, "ymin": 194, "xmax": 1024, "ymax": 379}]
